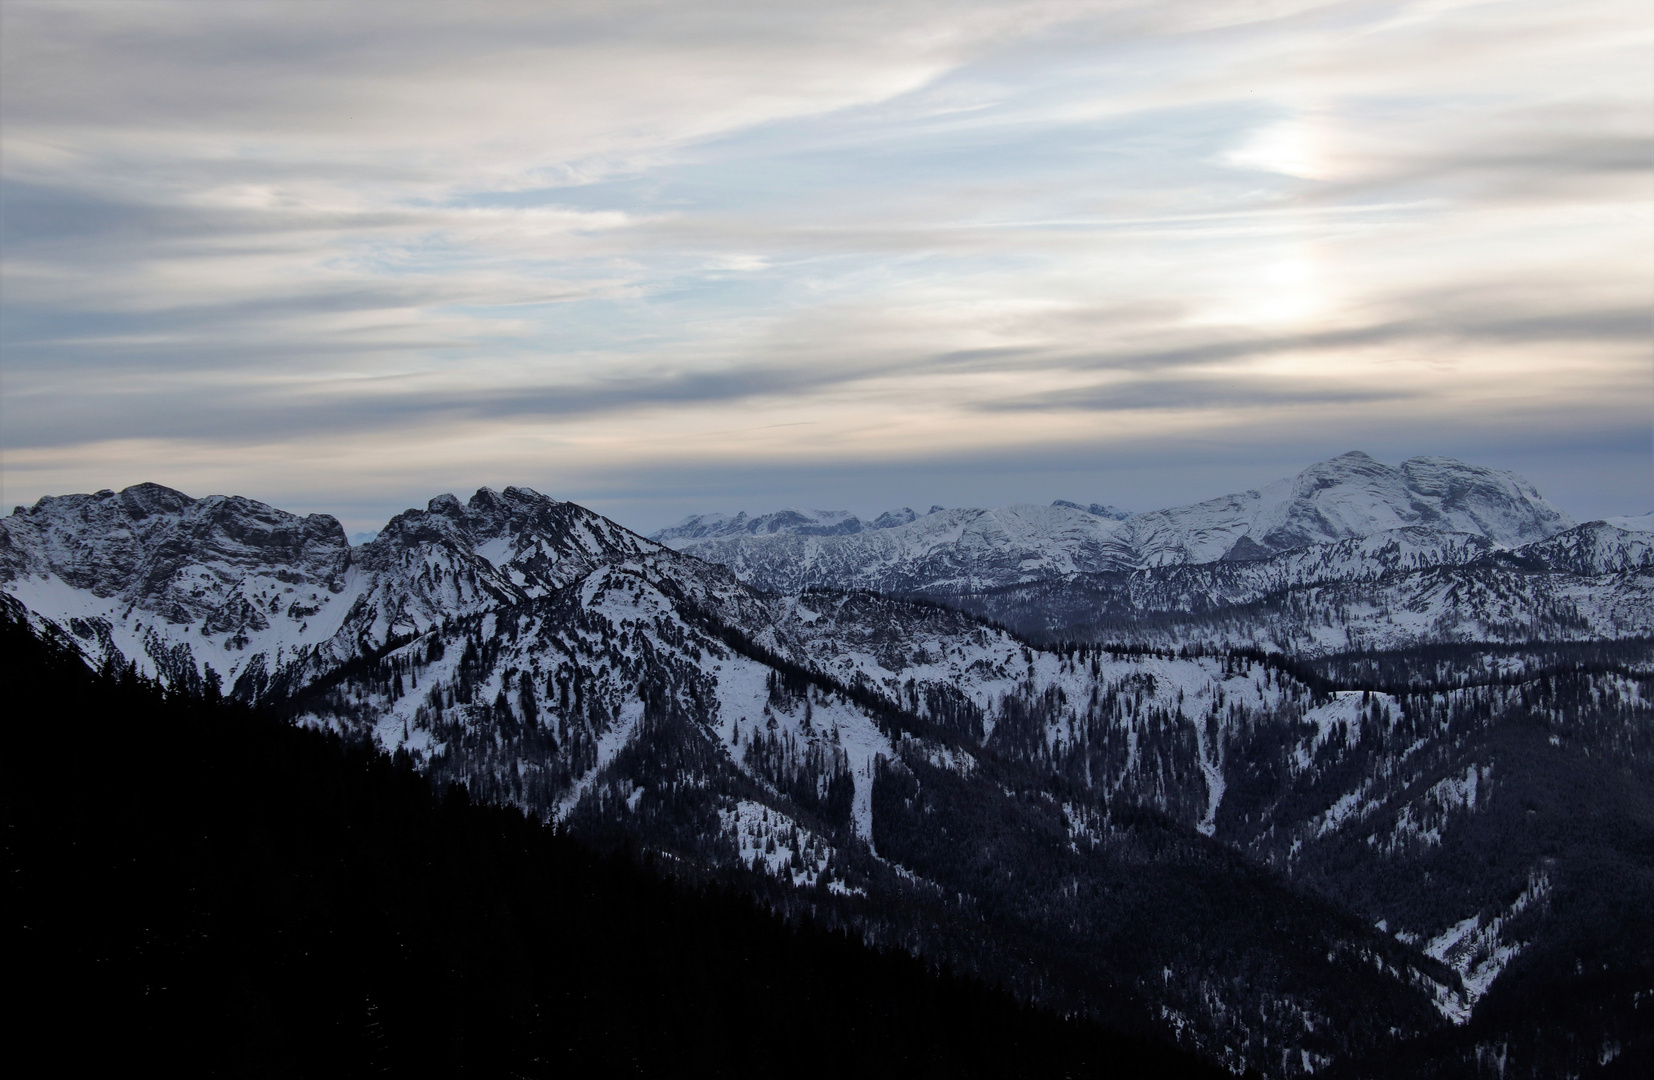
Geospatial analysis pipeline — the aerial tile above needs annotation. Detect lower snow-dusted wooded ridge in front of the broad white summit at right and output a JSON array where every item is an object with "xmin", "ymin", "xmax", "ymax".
[{"xmin": 943, "ymin": 521, "xmax": 1654, "ymax": 657}]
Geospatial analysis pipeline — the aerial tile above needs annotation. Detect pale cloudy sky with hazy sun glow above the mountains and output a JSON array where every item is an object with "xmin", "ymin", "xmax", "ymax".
[{"xmin": 0, "ymin": 0, "xmax": 1654, "ymax": 531}]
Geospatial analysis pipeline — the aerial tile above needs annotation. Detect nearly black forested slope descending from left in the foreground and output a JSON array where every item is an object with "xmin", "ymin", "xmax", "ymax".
[{"xmin": 0, "ymin": 614, "xmax": 1219, "ymax": 1077}]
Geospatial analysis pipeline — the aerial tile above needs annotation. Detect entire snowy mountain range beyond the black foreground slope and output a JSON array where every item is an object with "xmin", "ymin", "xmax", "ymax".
[{"xmin": 0, "ymin": 455, "xmax": 1654, "ymax": 1077}]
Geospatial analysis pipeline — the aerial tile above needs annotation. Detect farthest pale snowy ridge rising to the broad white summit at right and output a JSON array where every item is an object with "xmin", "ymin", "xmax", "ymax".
[{"xmin": 655, "ymin": 452, "xmax": 1573, "ymax": 595}]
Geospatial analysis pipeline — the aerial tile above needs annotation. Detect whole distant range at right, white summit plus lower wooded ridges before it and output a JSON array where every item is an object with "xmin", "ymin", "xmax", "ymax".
[{"xmin": 655, "ymin": 452, "xmax": 1654, "ymax": 653}]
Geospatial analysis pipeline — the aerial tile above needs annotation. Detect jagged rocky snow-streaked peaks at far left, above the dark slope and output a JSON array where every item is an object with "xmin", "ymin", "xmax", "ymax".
[{"xmin": 0, "ymin": 485, "xmax": 657, "ymax": 698}]
